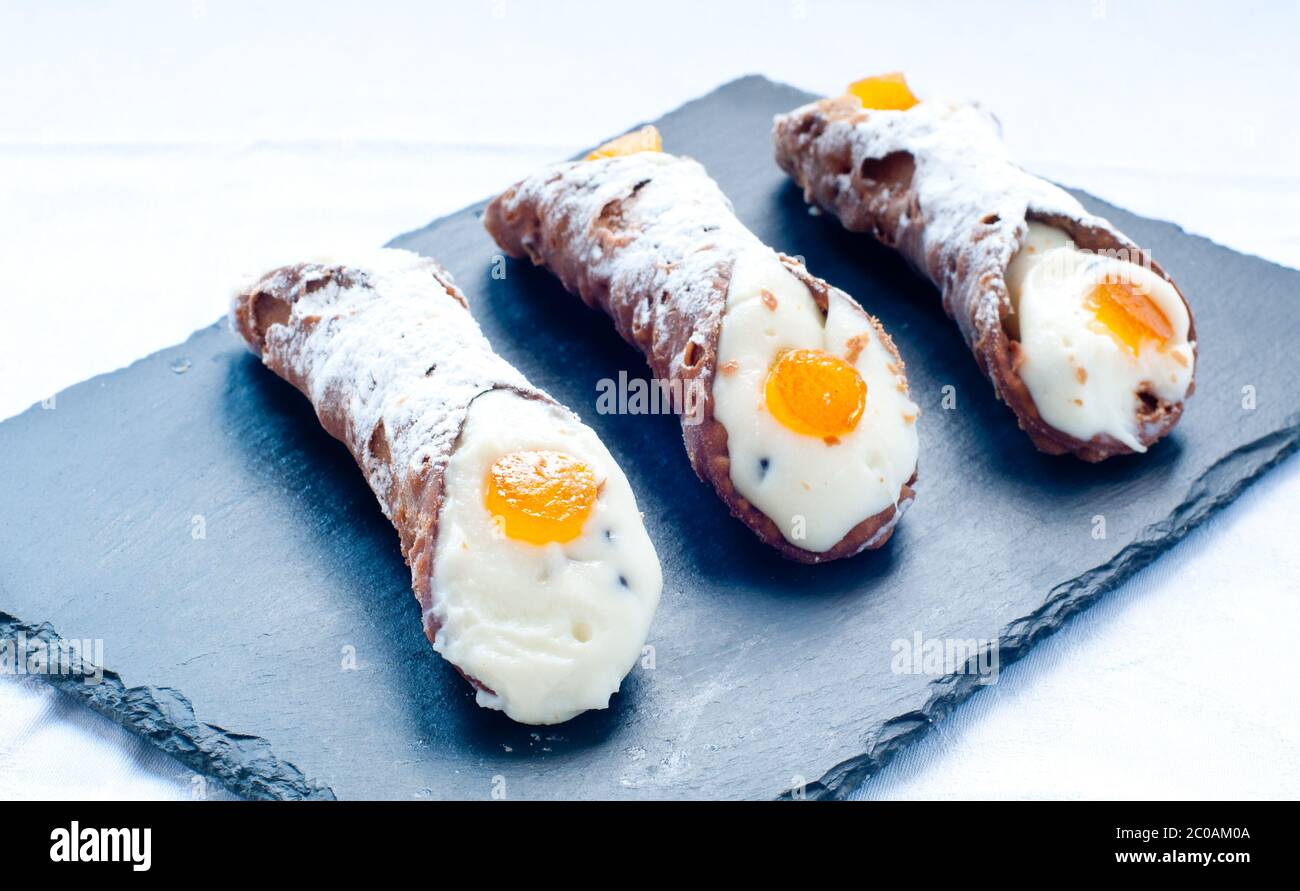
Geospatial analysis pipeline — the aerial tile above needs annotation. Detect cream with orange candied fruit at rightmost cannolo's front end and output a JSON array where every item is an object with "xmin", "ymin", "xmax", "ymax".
[{"xmin": 1006, "ymin": 222, "xmax": 1195, "ymax": 451}]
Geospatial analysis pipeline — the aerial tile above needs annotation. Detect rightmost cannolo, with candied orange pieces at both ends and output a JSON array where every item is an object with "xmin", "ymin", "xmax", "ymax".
[{"xmin": 772, "ymin": 74, "xmax": 1196, "ymax": 462}]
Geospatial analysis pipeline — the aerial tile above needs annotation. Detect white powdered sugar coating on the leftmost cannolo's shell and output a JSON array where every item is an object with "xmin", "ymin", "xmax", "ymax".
[{"xmin": 231, "ymin": 250, "xmax": 540, "ymax": 519}]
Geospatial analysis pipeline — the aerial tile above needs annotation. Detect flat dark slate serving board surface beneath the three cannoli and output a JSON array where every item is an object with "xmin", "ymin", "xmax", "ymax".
[{"xmin": 0, "ymin": 77, "xmax": 1300, "ymax": 799}]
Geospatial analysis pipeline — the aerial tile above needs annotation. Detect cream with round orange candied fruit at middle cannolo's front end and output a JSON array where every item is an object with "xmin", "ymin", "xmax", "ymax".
[{"xmin": 712, "ymin": 250, "xmax": 919, "ymax": 553}]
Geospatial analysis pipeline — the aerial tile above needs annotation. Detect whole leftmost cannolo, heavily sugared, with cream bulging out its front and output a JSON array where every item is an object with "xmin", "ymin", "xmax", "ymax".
[{"xmin": 231, "ymin": 250, "xmax": 662, "ymax": 725}]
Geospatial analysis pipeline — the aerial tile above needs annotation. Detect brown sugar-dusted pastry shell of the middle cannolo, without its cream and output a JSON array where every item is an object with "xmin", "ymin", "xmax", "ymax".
[{"xmin": 484, "ymin": 152, "xmax": 915, "ymax": 562}]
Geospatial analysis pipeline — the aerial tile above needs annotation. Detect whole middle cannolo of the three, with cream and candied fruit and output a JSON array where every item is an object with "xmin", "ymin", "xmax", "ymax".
[{"xmin": 484, "ymin": 127, "xmax": 919, "ymax": 563}]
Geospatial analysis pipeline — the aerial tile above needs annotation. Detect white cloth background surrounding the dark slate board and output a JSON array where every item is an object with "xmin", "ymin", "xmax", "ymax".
[{"xmin": 0, "ymin": 0, "xmax": 1300, "ymax": 797}]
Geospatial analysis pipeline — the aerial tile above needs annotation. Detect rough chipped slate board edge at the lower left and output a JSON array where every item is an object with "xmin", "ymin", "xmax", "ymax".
[{"xmin": 0, "ymin": 610, "xmax": 334, "ymax": 800}]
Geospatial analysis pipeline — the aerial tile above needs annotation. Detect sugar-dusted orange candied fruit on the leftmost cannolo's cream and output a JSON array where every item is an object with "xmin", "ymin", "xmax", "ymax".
[{"xmin": 484, "ymin": 449, "xmax": 599, "ymax": 545}]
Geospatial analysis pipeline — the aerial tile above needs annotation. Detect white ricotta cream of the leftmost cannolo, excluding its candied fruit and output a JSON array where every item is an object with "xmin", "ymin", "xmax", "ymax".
[{"xmin": 433, "ymin": 390, "xmax": 663, "ymax": 725}]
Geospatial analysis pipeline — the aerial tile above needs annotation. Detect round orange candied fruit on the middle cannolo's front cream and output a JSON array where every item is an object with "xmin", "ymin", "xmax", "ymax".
[{"xmin": 763, "ymin": 350, "xmax": 867, "ymax": 438}]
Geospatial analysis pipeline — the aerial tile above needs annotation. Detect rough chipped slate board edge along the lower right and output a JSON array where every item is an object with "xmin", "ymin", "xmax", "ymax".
[{"xmin": 780, "ymin": 415, "xmax": 1300, "ymax": 799}]
